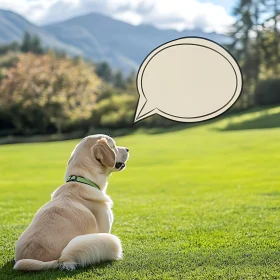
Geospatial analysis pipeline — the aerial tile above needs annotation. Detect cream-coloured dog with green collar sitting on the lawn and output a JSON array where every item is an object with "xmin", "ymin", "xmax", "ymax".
[{"xmin": 14, "ymin": 134, "xmax": 129, "ymax": 270}]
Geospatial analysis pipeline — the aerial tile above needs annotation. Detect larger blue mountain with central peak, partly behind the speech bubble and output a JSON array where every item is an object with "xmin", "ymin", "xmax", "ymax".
[{"xmin": 44, "ymin": 13, "xmax": 228, "ymax": 70}]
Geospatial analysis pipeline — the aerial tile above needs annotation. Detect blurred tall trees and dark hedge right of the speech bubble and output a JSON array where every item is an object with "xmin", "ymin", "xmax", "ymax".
[{"xmin": 226, "ymin": 0, "xmax": 280, "ymax": 110}]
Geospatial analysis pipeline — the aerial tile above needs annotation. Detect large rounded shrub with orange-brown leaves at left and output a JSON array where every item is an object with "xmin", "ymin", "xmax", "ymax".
[{"xmin": 0, "ymin": 53, "xmax": 101, "ymax": 133}]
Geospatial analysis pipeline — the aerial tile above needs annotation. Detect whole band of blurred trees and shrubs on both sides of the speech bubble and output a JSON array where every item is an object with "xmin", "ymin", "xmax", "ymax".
[{"xmin": 0, "ymin": 0, "xmax": 280, "ymax": 139}]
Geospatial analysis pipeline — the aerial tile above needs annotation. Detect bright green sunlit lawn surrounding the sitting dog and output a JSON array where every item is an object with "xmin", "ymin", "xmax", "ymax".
[{"xmin": 0, "ymin": 108, "xmax": 280, "ymax": 280}]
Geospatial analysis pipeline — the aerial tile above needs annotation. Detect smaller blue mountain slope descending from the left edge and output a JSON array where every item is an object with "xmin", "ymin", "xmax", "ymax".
[{"xmin": 0, "ymin": 10, "xmax": 83, "ymax": 55}]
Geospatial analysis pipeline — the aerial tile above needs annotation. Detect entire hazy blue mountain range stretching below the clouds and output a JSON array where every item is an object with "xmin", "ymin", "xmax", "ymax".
[{"xmin": 0, "ymin": 10, "xmax": 231, "ymax": 73}]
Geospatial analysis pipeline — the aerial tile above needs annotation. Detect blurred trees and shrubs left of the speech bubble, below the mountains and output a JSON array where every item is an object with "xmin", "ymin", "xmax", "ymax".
[{"xmin": 0, "ymin": 33, "xmax": 179, "ymax": 136}]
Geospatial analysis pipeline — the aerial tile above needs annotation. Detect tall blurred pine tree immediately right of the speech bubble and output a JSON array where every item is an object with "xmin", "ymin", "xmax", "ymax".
[{"xmin": 229, "ymin": 0, "xmax": 265, "ymax": 108}]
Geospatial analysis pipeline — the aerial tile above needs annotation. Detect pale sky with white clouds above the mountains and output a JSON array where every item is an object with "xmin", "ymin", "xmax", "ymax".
[{"xmin": 0, "ymin": 0, "xmax": 237, "ymax": 33}]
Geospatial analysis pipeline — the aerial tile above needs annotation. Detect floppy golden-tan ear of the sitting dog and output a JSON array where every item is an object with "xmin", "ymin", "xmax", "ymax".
[{"xmin": 91, "ymin": 138, "xmax": 116, "ymax": 168}]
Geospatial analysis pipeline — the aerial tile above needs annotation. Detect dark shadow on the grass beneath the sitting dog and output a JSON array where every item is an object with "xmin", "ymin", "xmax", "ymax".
[{"xmin": 1, "ymin": 259, "xmax": 114, "ymax": 280}]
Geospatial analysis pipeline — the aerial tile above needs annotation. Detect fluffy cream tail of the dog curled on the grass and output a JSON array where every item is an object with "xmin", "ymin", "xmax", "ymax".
[{"xmin": 14, "ymin": 233, "xmax": 122, "ymax": 271}]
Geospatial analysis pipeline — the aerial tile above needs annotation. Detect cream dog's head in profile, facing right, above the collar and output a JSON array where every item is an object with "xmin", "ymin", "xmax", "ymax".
[{"xmin": 68, "ymin": 134, "xmax": 129, "ymax": 178}]
